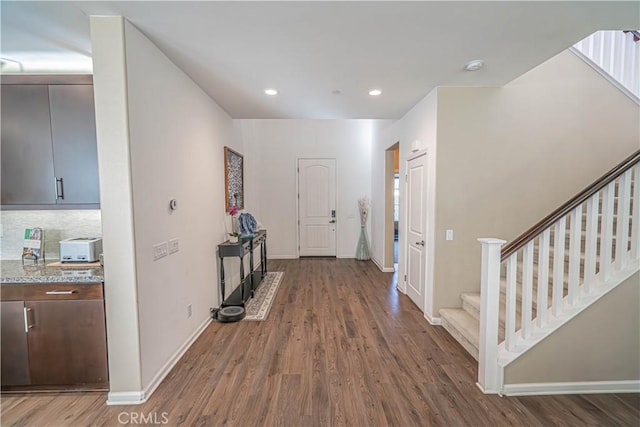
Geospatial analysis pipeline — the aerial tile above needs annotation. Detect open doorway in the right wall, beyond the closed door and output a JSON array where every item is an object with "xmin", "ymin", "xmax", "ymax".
[{"xmin": 383, "ymin": 142, "xmax": 400, "ymax": 272}]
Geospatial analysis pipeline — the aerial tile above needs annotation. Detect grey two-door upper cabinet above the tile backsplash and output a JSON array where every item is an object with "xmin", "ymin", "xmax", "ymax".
[{"xmin": 1, "ymin": 77, "xmax": 100, "ymax": 209}]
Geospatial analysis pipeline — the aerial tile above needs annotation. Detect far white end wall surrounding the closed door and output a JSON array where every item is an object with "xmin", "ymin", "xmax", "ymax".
[{"xmin": 236, "ymin": 120, "xmax": 374, "ymax": 258}]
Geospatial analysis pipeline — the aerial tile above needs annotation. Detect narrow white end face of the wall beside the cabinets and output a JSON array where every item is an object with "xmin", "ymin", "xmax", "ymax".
[{"xmin": 91, "ymin": 17, "xmax": 143, "ymax": 401}]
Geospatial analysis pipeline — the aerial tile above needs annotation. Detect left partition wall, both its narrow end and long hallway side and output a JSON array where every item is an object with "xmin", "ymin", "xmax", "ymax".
[{"xmin": 92, "ymin": 17, "xmax": 239, "ymax": 398}]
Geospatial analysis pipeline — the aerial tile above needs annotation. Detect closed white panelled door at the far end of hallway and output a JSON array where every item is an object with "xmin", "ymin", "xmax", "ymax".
[{"xmin": 298, "ymin": 159, "xmax": 336, "ymax": 256}]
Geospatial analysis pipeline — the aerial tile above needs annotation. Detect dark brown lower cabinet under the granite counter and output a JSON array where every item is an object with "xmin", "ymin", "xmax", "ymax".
[{"xmin": 0, "ymin": 284, "xmax": 108, "ymax": 390}]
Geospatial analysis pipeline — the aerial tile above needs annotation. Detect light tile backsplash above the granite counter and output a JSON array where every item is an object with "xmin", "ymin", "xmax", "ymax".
[{"xmin": 0, "ymin": 209, "xmax": 102, "ymax": 260}]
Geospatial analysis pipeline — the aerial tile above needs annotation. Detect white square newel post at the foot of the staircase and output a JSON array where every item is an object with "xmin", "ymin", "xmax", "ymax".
[{"xmin": 478, "ymin": 238, "xmax": 506, "ymax": 394}]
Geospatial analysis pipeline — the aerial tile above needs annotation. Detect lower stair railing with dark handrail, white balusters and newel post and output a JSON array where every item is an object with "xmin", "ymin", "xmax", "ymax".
[{"xmin": 478, "ymin": 150, "xmax": 640, "ymax": 393}]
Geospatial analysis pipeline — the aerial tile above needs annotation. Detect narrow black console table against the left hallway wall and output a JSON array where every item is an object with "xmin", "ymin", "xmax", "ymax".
[{"xmin": 218, "ymin": 230, "xmax": 267, "ymax": 307}]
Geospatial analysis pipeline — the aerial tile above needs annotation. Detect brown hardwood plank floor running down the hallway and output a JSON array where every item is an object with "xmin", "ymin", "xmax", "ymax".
[{"xmin": 1, "ymin": 258, "xmax": 640, "ymax": 426}]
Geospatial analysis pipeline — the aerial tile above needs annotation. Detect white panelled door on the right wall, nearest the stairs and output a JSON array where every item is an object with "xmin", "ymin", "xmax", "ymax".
[{"xmin": 406, "ymin": 154, "xmax": 427, "ymax": 312}]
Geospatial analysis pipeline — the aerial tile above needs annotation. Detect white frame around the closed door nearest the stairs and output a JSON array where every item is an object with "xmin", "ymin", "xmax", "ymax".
[{"xmin": 398, "ymin": 148, "xmax": 440, "ymax": 325}]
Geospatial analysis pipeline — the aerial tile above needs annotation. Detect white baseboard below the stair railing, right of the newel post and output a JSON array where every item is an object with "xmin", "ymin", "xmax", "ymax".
[{"xmin": 502, "ymin": 380, "xmax": 640, "ymax": 396}]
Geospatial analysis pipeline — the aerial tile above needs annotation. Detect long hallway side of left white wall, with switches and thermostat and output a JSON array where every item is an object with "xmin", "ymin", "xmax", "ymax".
[{"xmin": 122, "ymin": 23, "xmax": 235, "ymax": 387}]
